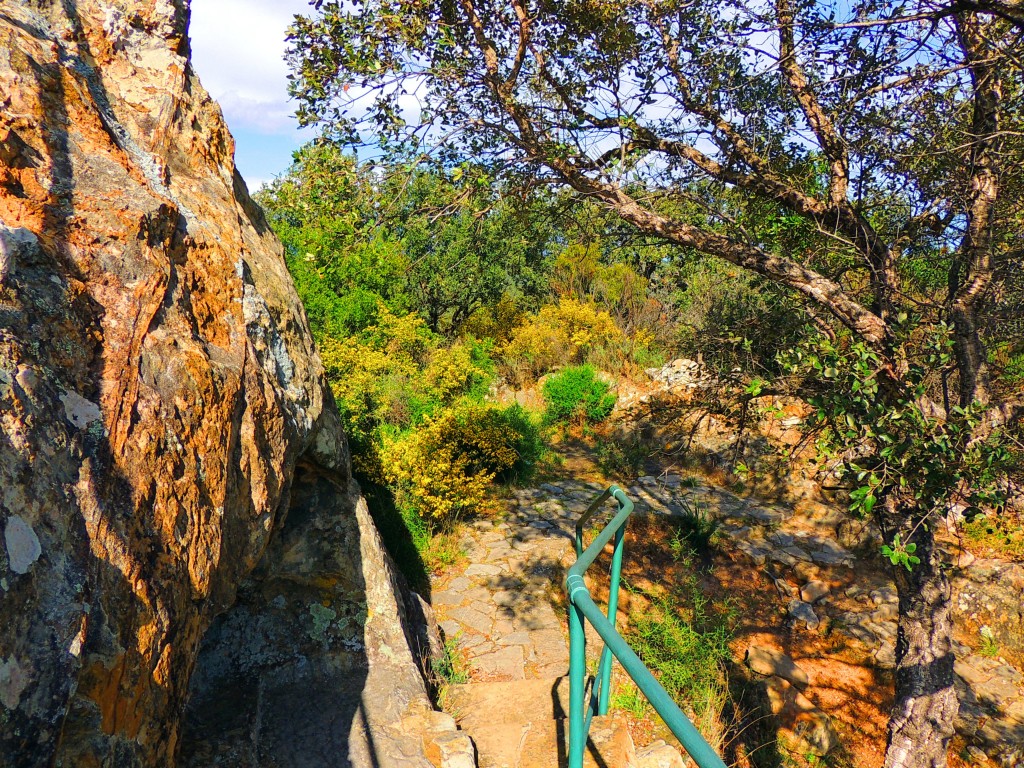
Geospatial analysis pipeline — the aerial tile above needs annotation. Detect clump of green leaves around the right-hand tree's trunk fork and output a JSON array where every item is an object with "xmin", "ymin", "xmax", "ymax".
[{"xmin": 785, "ymin": 325, "xmax": 1011, "ymax": 568}]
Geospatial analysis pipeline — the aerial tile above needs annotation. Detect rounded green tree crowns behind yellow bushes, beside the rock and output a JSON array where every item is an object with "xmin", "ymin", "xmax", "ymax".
[{"xmin": 257, "ymin": 141, "xmax": 546, "ymax": 338}]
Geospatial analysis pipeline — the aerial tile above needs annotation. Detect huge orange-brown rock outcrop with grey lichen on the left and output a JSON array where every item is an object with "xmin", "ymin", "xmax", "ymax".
[{"xmin": 0, "ymin": 0, "xmax": 446, "ymax": 768}]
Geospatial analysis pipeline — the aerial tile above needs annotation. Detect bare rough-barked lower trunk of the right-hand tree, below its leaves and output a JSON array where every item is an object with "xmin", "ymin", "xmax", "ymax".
[{"xmin": 885, "ymin": 516, "xmax": 959, "ymax": 768}]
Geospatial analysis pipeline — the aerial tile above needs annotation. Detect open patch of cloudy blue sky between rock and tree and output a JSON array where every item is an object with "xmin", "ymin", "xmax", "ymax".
[{"xmin": 189, "ymin": 0, "xmax": 314, "ymax": 190}]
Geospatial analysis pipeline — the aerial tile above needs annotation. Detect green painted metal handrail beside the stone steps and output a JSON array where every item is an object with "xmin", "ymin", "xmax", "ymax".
[{"xmin": 565, "ymin": 485, "xmax": 725, "ymax": 768}]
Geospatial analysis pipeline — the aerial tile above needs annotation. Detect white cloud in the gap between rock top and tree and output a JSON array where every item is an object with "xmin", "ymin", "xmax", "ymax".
[{"xmin": 189, "ymin": 0, "xmax": 312, "ymax": 134}]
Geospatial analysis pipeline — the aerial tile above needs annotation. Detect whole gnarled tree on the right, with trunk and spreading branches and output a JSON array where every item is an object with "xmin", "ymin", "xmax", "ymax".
[{"xmin": 282, "ymin": 0, "xmax": 1024, "ymax": 766}]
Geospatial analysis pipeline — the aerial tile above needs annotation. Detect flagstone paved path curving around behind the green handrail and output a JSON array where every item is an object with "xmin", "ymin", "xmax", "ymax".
[{"xmin": 432, "ymin": 474, "xmax": 1024, "ymax": 766}]
